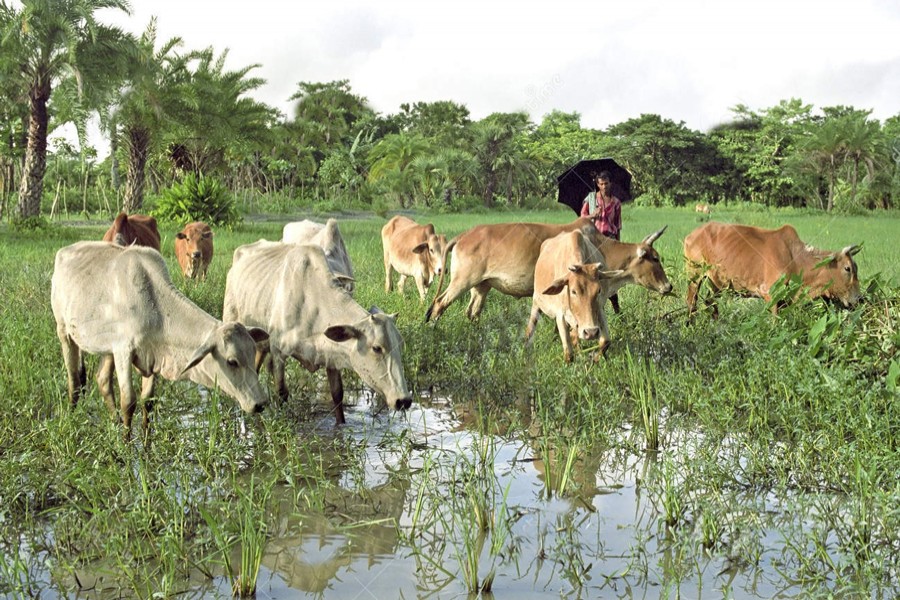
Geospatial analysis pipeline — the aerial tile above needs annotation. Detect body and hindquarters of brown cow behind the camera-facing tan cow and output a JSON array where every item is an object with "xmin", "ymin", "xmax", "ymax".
[{"xmin": 425, "ymin": 217, "xmax": 600, "ymax": 321}]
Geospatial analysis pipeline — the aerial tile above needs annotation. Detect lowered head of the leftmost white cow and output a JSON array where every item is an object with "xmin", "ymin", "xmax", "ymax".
[{"xmin": 181, "ymin": 323, "xmax": 269, "ymax": 413}]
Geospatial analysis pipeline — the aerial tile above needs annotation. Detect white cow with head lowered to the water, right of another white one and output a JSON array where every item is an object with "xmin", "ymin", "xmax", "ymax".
[{"xmin": 223, "ymin": 241, "xmax": 412, "ymax": 423}]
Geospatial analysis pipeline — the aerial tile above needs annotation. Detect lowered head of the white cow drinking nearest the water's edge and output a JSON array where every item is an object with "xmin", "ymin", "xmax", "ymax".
[{"xmin": 325, "ymin": 309, "xmax": 412, "ymax": 409}]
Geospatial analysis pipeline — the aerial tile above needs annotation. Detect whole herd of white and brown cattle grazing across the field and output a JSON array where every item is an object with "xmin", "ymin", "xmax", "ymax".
[{"xmin": 51, "ymin": 213, "xmax": 860, "ymax": 433}]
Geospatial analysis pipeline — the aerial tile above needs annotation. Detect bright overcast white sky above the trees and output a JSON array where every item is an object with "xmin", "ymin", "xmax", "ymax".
[{"xmin": 95, "ymin": 0, "xmax": 900, "ymax": 131}]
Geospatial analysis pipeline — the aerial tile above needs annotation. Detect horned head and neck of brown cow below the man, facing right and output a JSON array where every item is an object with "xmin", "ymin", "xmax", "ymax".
[{"xmin": 595, "ymin": 227, "xmax": 672, "ymax": 314}]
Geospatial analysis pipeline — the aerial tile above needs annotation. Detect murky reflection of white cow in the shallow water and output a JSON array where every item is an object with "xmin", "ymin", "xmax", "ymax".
[{"xmin": 262, "ymin": 464, "xmax": 410, "ymax": 592}]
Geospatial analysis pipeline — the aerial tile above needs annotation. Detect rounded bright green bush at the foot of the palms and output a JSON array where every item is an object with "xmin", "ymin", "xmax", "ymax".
[{"xmin": 151, "ymin": 173, "xmax": 241, "ymax": 227}]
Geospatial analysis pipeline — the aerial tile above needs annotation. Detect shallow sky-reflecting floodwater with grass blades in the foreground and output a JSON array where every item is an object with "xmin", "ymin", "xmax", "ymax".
[{"xmin": 3, "ymin": 397, "xmax": 900, "ymax": 598}]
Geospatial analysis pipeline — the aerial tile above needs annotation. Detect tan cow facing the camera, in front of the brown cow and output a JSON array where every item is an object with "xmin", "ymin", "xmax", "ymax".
[{"xmin": 525, "ymin": 230, "xmax": 625, "ymax": 362}]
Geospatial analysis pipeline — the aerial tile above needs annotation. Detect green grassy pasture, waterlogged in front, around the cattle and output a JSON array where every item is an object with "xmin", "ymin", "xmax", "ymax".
[{"xmin": 0, "ymin": 205, "xmax": 900, "ymax": 598}]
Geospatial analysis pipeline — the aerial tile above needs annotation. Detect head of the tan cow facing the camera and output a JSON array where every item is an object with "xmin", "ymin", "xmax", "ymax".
[{"xmin": 541, "ymin": 262, "xmax": 626, "ymax": 350}]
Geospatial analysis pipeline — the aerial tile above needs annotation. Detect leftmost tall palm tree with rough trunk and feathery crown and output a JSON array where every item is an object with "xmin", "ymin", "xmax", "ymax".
[{"xmin": 0, "ymin": 0, "xmax": 129, "ymax": 219}]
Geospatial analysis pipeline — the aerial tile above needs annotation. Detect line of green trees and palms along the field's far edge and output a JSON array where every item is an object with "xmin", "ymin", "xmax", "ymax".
[{"xmin": 0, "ymin": 0, "xmax": 900, "ymax": 225}]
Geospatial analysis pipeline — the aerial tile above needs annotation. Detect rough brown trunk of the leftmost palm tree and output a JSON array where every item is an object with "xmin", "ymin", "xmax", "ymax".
[{"xmin": 19, "ymin": 83, "xmax": 50, "ymax": 219}]
